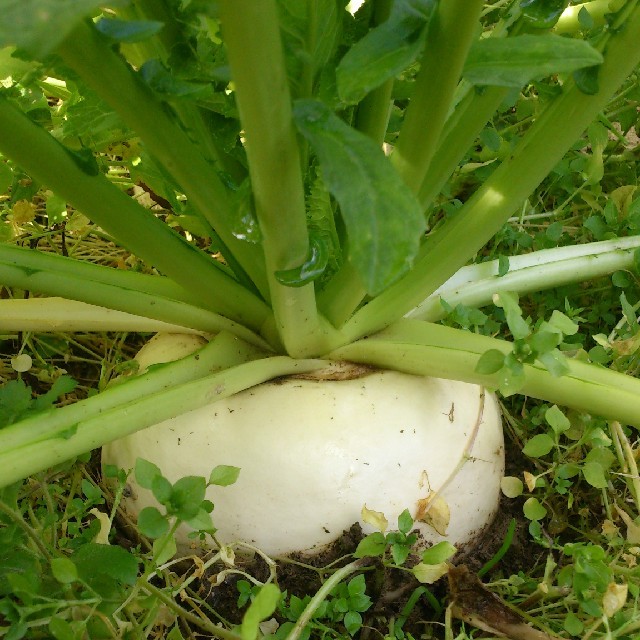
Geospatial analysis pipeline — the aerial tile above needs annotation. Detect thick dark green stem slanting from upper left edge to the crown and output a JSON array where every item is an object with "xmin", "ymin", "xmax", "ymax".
[{"xmin": 0, "ymin": 98, "xmax": 270, "ymax": 336}]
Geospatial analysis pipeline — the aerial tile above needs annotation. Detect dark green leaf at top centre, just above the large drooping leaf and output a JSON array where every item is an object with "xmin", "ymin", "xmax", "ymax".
[{"xmin": 336, "ymin": 0, "xmax": 436, "ymax": 104}]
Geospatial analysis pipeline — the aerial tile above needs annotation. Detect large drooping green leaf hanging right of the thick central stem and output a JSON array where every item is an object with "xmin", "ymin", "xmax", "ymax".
[{"xmin": 293, "ymin": 100, "xmax": 425, "ymax": 295}]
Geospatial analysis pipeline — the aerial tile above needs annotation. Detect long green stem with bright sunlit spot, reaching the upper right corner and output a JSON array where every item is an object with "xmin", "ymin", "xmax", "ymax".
[{"xmin": 342, "ymin": 7, "xmax": 640, "ymax": 340}]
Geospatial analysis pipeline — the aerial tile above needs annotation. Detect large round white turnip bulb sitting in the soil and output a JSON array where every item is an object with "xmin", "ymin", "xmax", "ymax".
[{"xmin": 103, "ymin": 339, "xmax": 504, "ymax": 556}]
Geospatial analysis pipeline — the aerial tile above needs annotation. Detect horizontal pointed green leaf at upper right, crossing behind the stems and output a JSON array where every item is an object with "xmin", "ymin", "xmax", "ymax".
[{"xmin": 463, "ymin": 33, "xmax": 603, "ymax": 88}]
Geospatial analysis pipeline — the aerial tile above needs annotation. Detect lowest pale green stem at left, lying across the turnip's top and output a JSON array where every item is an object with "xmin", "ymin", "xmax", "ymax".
[{"xmin": 0, "ymin": 356, "xmax": 327, "ymax": 487}]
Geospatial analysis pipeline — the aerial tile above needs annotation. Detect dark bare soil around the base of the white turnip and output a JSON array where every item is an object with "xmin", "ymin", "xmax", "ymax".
[{"xmin": 149, "ymin": 432, "xmax": 545, "ymax": 640}]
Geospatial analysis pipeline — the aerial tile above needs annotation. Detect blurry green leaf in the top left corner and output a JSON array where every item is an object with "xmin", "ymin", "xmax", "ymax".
[{"xmin": 0, "ymin": 0, "xmax": 114, "ymax": 59}]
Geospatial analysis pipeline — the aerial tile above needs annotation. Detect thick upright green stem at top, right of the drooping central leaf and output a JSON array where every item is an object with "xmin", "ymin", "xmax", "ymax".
[{"xmin": 391, "ymin": 0, "xmax": 484, "ymax": 193}]
